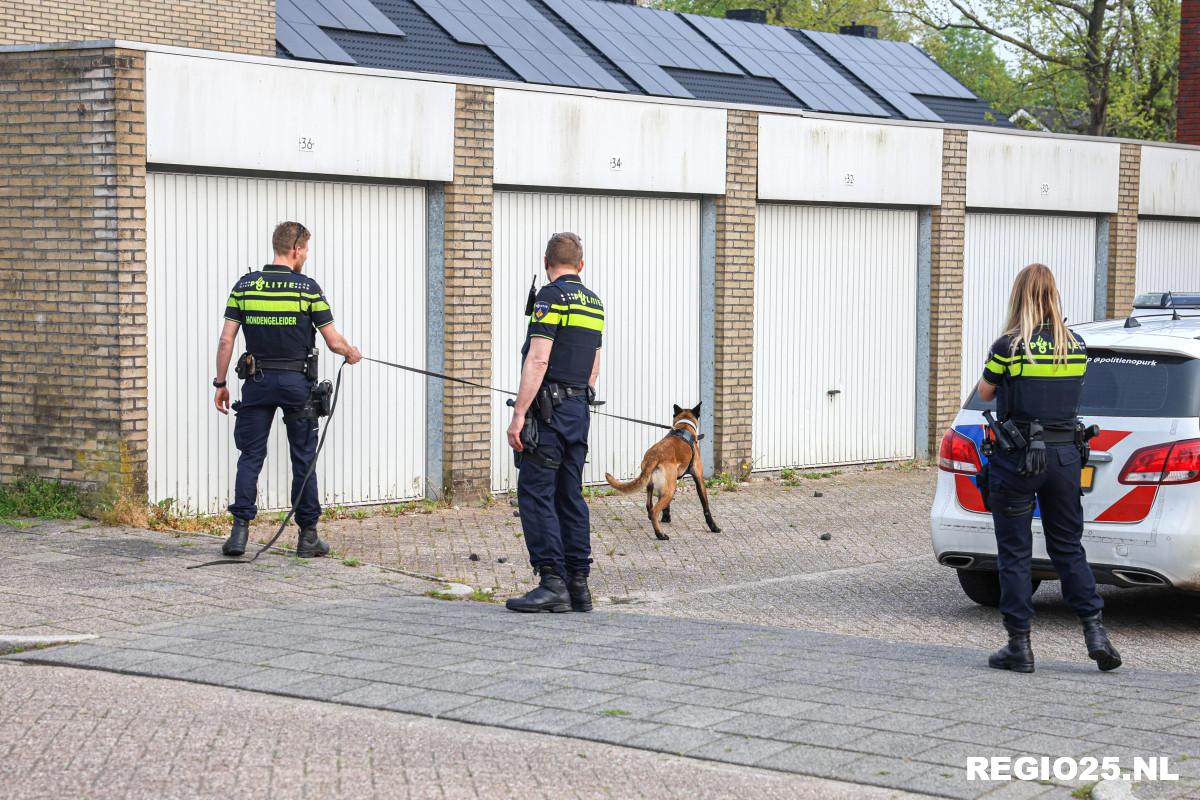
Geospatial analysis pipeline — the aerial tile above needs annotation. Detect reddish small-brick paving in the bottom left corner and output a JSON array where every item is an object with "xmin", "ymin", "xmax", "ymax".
[{"xmin": 0, "ymin": 664, "xmax": 910, "ymax": 800}]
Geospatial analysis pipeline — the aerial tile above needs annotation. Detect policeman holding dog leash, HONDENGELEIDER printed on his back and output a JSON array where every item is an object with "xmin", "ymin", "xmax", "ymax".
[{"xmin": 212, "ymin": 222, "xmax": 362, "ymax": 558}]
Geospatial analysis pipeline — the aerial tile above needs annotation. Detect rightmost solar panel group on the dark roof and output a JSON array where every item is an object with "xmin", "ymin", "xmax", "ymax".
[{"xmin": 804, "ymin": 30, "xmax": 976, "ymax": 121}]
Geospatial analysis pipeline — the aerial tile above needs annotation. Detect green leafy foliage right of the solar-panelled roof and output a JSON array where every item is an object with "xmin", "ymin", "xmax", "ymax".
[{"xmin": 892, "ymin": 0, "xmax": 1180, "ymax": 140}]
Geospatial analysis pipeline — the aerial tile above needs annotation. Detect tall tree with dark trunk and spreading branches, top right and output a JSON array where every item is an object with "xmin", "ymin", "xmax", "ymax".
[{"xmin": 896, "ymin": 0, "xmax": 1180, "ymax": 138}]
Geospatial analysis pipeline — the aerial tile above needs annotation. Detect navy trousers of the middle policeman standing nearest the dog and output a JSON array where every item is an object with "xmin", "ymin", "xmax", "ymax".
[{"xmin": 517, "ymin": 397, "xmax": 592, "ymax": 577}]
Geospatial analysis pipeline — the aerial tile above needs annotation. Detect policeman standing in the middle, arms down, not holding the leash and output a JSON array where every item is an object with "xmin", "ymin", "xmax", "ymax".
[{"xmin": 505, "ymin": 233, "xmax": 604, "ymax": 612}]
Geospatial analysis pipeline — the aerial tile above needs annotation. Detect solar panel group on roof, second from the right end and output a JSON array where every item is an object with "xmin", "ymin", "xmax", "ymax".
[{"xmin": 683, "ymin": 14, "xmax": 889, "ymax": 116}]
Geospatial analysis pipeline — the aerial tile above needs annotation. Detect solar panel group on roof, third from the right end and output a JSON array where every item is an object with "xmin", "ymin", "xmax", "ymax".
[{"xmin": 546, "ymin": 0, "xmax": 742, "ymax": 97}]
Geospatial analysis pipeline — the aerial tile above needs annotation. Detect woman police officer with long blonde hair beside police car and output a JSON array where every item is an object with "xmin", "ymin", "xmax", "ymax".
[{"xmin": 978, "ymin": 264, "xmax": 1121, "ymax": 673}]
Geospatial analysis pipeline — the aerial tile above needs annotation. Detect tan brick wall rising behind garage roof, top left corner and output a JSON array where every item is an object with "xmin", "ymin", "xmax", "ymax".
[{"xmin": 0, "ymin": 0, "xmax": 275, "ymax": 55}]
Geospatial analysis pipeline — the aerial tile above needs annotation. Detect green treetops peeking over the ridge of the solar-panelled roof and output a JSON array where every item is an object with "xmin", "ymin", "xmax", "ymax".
[{"xmin": 654, "ymin": 0, "xmax": 916, "ymax": 42}]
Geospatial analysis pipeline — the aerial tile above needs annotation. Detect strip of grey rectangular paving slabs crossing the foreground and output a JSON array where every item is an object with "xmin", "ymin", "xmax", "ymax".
[{"xmin": 10, "ymin": 596, "xmax": 1200, "ymax": 798}]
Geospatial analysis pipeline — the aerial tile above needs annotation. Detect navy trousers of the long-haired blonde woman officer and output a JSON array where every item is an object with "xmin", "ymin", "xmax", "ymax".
[{"xmin": 989, "ymin": 444, "xmax": 1104, "ymax": 630}]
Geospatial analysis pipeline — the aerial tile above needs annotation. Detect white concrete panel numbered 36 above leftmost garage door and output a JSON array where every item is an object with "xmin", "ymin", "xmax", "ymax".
[{"xmin": 146, "ymin": 53, "xmax": 455, "ymax": 181}]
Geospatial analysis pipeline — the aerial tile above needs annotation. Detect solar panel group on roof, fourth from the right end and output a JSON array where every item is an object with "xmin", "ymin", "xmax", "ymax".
[{"xmin": 408, "ymin": 0, "xmax": 625, "ymax": 91}]
